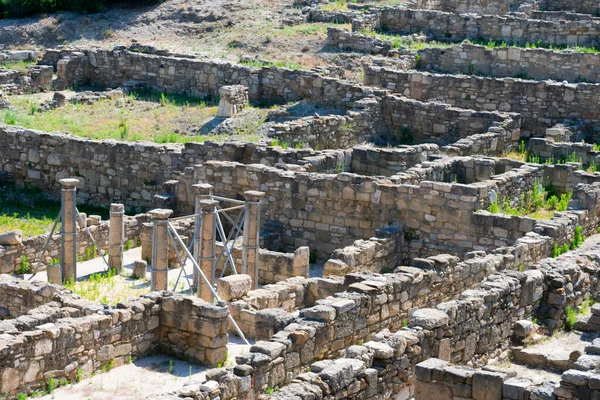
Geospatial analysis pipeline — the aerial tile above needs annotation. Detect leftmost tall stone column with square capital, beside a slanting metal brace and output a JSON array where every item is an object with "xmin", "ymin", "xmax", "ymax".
[{"xmin": 59, "ymin": 179, "xmax": 79, "ymax": 283}]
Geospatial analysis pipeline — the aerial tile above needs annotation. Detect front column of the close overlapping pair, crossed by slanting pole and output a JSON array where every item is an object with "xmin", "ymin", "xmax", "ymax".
[{"xmin": 198, "ymin": 200, "xmax": 219, "ymax": 303}]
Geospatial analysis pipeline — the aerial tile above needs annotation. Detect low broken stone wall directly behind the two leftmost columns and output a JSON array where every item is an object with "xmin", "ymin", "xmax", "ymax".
[{"xmin": 0, "ymin": 214, "xmax": 149, "ymax": 274}]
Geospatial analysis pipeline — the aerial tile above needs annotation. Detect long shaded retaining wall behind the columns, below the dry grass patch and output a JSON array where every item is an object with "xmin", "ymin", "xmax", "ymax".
[{"xmin": 0, "ymin": 127, "xmax": 336, "ymax": 211}]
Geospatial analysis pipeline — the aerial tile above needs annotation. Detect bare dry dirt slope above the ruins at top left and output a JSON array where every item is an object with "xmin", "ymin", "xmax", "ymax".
[{"xmin": 0, "ymin": 0, "xmax": 352, "ymax": 67}]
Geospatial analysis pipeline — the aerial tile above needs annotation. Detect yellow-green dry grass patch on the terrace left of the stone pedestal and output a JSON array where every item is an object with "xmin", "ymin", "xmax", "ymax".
[{"xmin": 0, "ymin": 91, "xmax": 264, "ymax": 143}]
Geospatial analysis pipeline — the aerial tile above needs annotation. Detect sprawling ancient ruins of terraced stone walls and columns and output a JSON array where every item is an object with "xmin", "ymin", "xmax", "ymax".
[{"xmin": 0, "ymin": 0, "xmax": 600, "ymax": 400}]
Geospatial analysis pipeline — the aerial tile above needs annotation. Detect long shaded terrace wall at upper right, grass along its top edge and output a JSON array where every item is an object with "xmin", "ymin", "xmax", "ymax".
[{"xmin": 418, "ymin": 44, "xmax": 600, "ymax": 83}]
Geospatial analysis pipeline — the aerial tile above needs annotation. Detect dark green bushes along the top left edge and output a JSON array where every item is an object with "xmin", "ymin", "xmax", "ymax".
[{"xmin": 0, "ymin": 0, "xmax": 162, "ymax": 18}]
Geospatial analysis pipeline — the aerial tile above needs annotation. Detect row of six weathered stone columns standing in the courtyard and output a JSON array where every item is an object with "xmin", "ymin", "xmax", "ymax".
[{"xmin": 60, "ymin": 179, "xmax": 265, "ymax": 301}]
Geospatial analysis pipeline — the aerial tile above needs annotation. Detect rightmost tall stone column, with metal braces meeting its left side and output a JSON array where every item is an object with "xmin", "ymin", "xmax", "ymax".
[{"xmin": 243, "ymin": 190, "xmax": 265, "ymax": 289}]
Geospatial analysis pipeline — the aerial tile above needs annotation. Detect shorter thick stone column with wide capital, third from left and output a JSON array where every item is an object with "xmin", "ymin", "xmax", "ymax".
[{"xmin": 149, "ymin": 208, "xmax": 173, "ymax": 292}]
